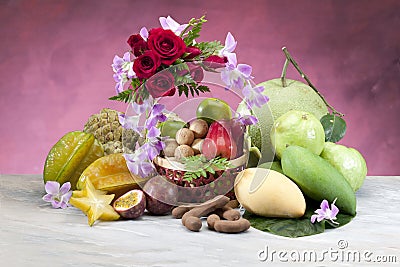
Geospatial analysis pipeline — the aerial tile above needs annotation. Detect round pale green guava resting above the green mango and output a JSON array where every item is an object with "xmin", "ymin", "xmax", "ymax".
[{"xmin": 270, "ymin": 110, "xmax": 325, "ymax": 159}]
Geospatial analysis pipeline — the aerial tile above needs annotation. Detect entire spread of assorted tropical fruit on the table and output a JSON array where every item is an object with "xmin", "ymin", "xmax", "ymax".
[{"xmin": 43, "ymin": 39, "xmax": 367, "ymax": 237}]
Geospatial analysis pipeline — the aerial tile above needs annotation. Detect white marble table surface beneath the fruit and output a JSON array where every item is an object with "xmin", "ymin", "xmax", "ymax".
[{"xmin": 0, "ymin": 175, "xmax": 400, "ymax": 267}]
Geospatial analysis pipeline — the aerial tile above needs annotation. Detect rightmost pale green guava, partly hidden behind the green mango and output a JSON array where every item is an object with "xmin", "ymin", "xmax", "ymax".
[{"xmin": 320, "ymin": 142, "xmax": 367, "ymax": 192}]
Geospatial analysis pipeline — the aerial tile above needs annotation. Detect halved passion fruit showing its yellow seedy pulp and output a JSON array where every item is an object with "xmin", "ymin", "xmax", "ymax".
[{"xmin": 113, "ymin": 189, "xmax": 146, "ymax": 219}]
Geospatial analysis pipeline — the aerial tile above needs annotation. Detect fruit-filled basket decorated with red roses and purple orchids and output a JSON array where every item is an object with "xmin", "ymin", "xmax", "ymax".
[{"xmin": 111, "ymin": 17, "xmax": 268, "ymax": 205}]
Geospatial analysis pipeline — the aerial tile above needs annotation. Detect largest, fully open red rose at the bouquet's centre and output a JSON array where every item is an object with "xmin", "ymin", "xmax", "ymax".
[{"xmin": 147, "ymin": 28, "xmax": 186, "ymax": 66}]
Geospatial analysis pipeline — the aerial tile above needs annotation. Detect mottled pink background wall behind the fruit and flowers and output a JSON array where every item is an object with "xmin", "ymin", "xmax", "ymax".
[{"xmin": 0, "ymin": 0, "xmax": 400, "ymax": 175}]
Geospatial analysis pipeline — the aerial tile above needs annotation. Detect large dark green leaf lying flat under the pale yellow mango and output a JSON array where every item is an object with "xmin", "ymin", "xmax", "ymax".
[{"xmin": 243, "ymin": 200, "xmax": 354, "ymax": 238}]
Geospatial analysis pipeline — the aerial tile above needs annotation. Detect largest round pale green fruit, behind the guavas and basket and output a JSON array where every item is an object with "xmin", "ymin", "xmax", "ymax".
[{"xmin": 238, "ymin": 78, "xmax": 328, "ymax": 163}]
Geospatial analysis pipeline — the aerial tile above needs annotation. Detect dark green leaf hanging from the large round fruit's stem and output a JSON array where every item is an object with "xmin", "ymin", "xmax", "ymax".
[{"xmin": 321, "ymin": 114, "xmax": 346, "ymax": 143}]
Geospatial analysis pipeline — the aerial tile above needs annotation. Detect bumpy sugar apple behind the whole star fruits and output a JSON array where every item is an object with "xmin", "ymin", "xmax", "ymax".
[{"xmin": 83, "ymin": 108, "xmax": 138, "ymax": 155}]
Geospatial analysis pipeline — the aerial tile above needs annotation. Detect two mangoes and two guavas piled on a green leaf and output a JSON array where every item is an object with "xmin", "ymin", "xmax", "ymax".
[{"xmin": 235, "ymin": 107, "xmax": 367, "ymax": 237}]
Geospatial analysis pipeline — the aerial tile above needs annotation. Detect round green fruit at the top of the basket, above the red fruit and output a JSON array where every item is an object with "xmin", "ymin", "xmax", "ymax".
[{"xmin": 196, "ymin": 98, "xmax": 232, "ymax": 124}]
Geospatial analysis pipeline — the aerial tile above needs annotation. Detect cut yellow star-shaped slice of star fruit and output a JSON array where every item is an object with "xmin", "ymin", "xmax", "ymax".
[{"xmin": 69, "ymin": 179, "xmax": 120, "ymax": 226}]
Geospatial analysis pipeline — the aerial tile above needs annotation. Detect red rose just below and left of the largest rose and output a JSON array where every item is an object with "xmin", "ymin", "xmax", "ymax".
[{"xmin": 133, "ymin": 50, "xmax": 161, "ymax": 79}]
